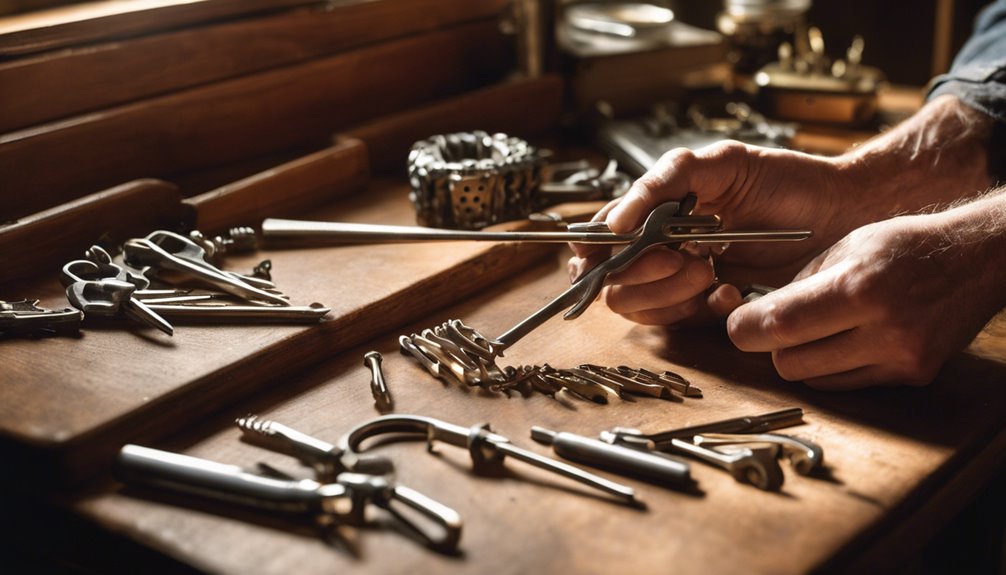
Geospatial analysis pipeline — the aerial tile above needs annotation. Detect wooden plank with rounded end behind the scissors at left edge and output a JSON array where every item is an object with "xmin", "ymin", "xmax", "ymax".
[{"xmin": 0, "ymin": 180, "xmax": 193, "ymax": 287}]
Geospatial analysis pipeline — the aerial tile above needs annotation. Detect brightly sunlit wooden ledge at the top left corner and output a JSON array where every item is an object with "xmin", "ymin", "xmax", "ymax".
[{"xmin": 0, "ymin": 0, "xmax": 319, "ymax": 56}]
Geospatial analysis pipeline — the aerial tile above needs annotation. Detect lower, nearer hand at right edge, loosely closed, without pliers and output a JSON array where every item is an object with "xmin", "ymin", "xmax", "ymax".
[{"xmin": 727, "ymin": 195, "xmax": 1006, "ymax": 390}]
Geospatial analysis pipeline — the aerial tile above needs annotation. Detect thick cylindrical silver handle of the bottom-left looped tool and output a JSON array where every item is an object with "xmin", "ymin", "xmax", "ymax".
[{"xmin": 116, "ymin": 444, "xmax": 347, "ymax": 513}]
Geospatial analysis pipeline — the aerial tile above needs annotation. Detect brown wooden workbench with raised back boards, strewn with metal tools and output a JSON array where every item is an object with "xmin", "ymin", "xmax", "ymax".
[{"xmin": 0, "ymin": 0, "xmax": 1006, "ymax": 574}]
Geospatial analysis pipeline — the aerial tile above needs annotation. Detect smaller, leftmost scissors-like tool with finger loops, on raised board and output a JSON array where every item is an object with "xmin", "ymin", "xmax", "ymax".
[{"xmin": 61, "ymin": 259, "xmax": 174, "ymax": 336}]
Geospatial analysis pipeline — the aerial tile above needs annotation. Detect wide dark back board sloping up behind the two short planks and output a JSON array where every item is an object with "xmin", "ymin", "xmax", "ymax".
[{"xmin": 0, "ymin": 22, "xmax": 511, "ymax": 219}]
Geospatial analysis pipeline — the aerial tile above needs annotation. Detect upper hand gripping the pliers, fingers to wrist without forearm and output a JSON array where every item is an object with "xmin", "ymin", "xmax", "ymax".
[{"xmin": 569, "ymin": 142, "xmax": 861, "ymax": 325}]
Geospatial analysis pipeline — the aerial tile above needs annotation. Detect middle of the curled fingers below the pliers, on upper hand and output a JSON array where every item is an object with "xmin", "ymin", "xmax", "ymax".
[{"xmin": 605, "ymin": 258, "xmax": 714, "ymax": 316}]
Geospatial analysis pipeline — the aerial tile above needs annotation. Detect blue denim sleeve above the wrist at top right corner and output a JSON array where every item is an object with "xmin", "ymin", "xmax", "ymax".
[{"xmin": 928, "ymin": 0, "xmax": 1006, "ymax": 123}]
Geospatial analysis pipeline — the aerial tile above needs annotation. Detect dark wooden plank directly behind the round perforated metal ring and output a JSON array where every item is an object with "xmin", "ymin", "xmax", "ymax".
[{"xmin": 346, "ymin": 75, "xmax": 562, "ymax": 172}]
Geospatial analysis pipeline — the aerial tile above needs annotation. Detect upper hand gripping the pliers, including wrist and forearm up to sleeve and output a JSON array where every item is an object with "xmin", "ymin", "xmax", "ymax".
[{"xmin": 569, "ymin": 97, "xmax": 993, "ymax": 325}]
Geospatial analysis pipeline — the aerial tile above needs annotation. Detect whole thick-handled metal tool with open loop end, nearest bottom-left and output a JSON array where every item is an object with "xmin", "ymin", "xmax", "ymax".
[{"xmin": 116, "ymin": 445, "xmax": 462, "ymax": 552}]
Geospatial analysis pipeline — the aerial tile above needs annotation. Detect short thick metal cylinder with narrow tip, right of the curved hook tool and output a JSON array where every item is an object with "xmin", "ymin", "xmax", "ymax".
[{"xmin": 531, "ymin": 426, "xmax": 691, "ymax": 486}]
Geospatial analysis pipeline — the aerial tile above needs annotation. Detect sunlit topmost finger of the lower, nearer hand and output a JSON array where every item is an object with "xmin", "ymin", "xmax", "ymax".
[{"xmin": 726, "ymin": 265, "xmax": 873, "ymax": 352}]
